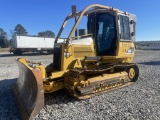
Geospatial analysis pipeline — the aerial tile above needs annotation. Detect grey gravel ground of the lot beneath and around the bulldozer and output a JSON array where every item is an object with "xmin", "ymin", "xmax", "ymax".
[{"xmin": 0, "ymin": 50, "xmax": 160, "ymax": 120}]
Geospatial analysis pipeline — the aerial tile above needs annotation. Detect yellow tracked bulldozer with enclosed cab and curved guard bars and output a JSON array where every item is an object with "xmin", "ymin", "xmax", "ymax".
[{"xmin": 12, "ymin": 4, "xmax": 139, "ymax": 119}]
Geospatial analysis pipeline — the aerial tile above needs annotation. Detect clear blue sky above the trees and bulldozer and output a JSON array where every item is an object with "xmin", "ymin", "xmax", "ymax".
[{"xmin": 0, "ymin": 0, "xmax": 160, "ymax": 41}]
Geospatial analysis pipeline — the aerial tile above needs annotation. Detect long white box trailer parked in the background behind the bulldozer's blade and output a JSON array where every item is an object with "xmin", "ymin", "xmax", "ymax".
[{"xmin": 10, "ymin": 35, "xmax": 65, "ymax": 55}]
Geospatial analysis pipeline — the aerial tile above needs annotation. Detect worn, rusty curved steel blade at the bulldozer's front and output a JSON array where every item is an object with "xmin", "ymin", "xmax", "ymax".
[{"xmin": 11, "ymin": 62, "xmax": 44, "ymax": 120}]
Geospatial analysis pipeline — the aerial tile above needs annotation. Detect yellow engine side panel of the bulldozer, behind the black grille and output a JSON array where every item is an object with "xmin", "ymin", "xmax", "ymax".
[{"xmin": 59, "ymin": 43, "xmax": 95, "ymax": 71}]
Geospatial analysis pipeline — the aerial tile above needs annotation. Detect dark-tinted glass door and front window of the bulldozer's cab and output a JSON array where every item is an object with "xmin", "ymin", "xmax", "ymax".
[{"xmin": 87, "ymin": 12, "xmax": 117, "ymax": 56}]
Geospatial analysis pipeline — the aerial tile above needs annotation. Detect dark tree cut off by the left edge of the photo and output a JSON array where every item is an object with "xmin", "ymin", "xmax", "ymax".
[{"xmin": 0, "ymin": 28, "xmax": 7, "ymax": 48}]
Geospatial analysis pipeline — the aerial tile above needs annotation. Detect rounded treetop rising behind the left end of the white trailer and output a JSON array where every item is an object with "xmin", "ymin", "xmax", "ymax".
[{"xmin": 14, "ymin": 24, "xmax": 28, "ymax": 35}]
